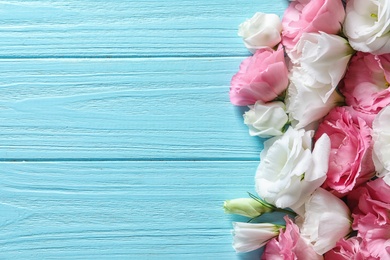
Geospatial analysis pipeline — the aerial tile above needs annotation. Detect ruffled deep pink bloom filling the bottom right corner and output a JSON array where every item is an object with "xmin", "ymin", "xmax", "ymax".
[{"xmin": 348, "ymin": 178, "xmax": 390, "ymax": 259}]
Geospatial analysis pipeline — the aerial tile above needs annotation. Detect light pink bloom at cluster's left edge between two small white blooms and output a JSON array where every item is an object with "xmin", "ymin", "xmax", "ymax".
[{"xmin": 229, "ymin": 48, "xmax": 288, "ymax": 106}]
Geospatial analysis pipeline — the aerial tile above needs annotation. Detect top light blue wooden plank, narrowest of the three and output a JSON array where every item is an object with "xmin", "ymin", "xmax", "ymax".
[{"xmin": 0, "ymin": 0, "xmax": 287, "ymax": 58}]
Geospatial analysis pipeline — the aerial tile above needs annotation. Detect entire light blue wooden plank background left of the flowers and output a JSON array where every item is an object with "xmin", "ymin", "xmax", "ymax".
[{"xmin": 0, "ymin": 0, "xmax": 287, "ymax": 259}]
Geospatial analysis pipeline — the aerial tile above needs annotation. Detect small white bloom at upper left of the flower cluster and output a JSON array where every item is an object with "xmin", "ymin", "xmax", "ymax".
[{"xmin": 238, "ymin": 13, "xmax": 282, "ymax": 53}]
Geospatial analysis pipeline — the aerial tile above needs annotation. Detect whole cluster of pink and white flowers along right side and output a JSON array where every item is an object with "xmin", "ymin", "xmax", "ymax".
[{"xmin": 224, "ymin": 0, "xmax": 390, "ymax": 260}]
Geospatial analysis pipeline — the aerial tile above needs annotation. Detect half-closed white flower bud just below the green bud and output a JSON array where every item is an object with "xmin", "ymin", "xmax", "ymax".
[{"xmin": 233, "ymin": 222, "xmax": 283, "ymax": 253}]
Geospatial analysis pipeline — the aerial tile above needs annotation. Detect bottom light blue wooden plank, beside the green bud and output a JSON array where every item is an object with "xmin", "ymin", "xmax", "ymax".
[{"xmin": 0, "ymin": 161, "xmax": 257, "ymax": 259}]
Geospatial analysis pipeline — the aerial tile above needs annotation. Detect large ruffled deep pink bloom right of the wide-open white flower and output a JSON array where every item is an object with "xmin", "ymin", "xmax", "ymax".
[{"xmin": 314, "ymin": 107, "xmax": 375, "ymax": 197}]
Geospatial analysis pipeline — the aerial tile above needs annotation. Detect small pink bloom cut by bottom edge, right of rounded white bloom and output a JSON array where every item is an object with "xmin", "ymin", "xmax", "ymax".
[{"xmin": 324, "ymin": 237, "xmax": 380, "ymax": 260}]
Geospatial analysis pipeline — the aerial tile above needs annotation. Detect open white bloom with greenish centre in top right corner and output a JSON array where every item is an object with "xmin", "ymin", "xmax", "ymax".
[{"xmin": 344, "ymin": 0, "xmax": 390, "ymax": 55}]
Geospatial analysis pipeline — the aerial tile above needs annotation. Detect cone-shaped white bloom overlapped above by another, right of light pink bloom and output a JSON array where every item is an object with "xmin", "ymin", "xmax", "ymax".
[{"xmin": 285, "ymin": 67, "xmax": 344, "ymax": 128}]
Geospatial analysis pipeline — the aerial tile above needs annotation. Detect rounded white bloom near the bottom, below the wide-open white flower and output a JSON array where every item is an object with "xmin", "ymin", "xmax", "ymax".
[{"xmin": 296, "ymin": 188, "xmax": 351, "ymax": 255}]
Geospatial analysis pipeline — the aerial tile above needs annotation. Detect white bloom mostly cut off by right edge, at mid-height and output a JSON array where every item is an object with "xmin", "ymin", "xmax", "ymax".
[{"xmin": 372, "ymin": 107, "xmax": 390, "ymax": 185}]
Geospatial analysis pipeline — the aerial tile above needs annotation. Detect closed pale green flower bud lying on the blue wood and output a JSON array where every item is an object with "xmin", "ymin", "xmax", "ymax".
[{"xmin": 223, "ymin": 198, "xmax": 274, "ymax": 218}]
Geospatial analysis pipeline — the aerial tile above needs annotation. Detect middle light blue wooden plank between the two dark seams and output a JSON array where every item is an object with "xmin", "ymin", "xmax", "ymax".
[{"xmin": 0, "ymin": 58, "xmax": 262, "ymax": 160}]
